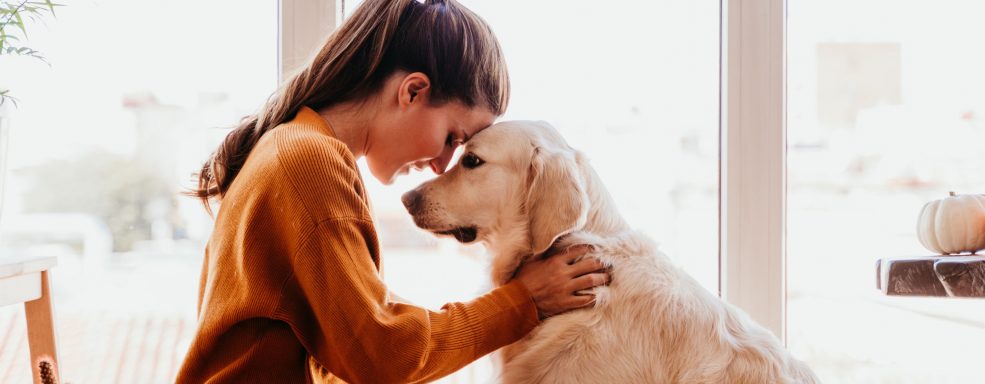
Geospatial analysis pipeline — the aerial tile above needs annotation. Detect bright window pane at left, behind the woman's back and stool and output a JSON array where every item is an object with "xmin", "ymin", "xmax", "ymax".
[{"xmin": 0, "ymin": 0, "xmax": 277, "ymax": 383}]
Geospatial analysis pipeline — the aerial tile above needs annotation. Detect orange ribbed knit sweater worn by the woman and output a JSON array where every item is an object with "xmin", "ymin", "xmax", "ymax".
[{"xmin": 171, "ymin": 108, "xmax": 538, "ymax": 383}]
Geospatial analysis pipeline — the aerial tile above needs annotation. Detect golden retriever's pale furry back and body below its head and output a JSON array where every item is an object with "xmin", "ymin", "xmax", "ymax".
[{"xmin": 503, "ymin": 231, "xmax": 817, "ymax": 383}]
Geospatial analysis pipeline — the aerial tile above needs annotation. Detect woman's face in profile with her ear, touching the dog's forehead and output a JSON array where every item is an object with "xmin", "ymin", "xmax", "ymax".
[{"xmin": 366, "ymin": 74, "xmax": 496, "ymax": 184}]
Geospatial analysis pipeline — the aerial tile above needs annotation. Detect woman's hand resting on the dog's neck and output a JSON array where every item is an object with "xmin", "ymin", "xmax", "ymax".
[{"xmin": 516, "ymin": 245, "xmax": 610, "ymax": 319}]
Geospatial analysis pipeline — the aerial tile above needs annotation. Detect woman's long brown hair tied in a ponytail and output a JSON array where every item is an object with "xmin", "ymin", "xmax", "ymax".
[{"xmin": 189, "ymin": 0, "xmax": 510, "ymax": 213}]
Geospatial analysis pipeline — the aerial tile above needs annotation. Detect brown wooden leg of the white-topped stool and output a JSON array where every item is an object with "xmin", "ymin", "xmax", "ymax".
[{"xmin": 24, "ymin": 271, "xmax": 59, "ymax": 384}]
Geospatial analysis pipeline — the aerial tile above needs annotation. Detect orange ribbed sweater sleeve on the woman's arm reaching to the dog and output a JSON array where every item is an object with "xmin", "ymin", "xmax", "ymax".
[{"xmin": 276, "ymin": 219, "xmax": 537, "ymax": 383}]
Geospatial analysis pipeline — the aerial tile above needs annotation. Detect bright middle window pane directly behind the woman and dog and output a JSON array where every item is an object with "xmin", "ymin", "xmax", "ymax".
[{"xmin": 346, "ymin": 0, "xmax": 719, "ymax": 382}]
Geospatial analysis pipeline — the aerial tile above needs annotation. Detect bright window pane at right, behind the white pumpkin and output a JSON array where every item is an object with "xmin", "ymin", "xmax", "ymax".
[{"xmin": 787, "ymin": 0, "xmax": 985, "ymax": 384}]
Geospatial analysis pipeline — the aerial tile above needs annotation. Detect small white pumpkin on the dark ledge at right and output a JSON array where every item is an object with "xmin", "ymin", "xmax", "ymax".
[{"xmin": 917, "ymin": 192, "xmax": 985, "ymax": 255}]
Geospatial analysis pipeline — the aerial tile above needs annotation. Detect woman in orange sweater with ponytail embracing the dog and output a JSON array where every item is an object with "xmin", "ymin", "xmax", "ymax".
[{"xmin": 178, "ymin": 0, "xmax": 608, "ymax": 383}]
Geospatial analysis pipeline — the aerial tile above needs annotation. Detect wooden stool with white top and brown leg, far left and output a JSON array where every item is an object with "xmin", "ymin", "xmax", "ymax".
[{"xmin": 0, "ymin": 256, "xmax": 59, "ymax": 384}]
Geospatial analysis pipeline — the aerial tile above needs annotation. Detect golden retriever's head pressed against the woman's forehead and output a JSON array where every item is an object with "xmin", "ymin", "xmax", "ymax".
[{"xmin": 402, "ymin": 121, "xmax": 589, "ymax": 254}]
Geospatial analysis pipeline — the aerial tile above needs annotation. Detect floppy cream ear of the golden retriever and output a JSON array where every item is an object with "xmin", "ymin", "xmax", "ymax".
[{"xmin": 526, "ymin": 146, "xmax": 589, "ymax": 255}]
